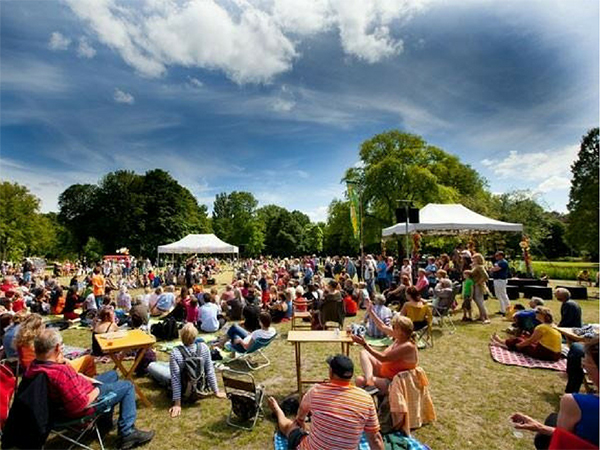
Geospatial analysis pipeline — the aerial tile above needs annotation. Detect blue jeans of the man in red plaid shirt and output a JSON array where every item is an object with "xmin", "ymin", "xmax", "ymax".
[{"xmin": 96, "ymin": 370, "xmax": 137, "ymax": 436}]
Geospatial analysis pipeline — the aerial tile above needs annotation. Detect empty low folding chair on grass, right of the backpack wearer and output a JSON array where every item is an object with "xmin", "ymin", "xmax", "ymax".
[{"xmin": 222, "ymin": 369, "xmax": 265, "ymax": 431}]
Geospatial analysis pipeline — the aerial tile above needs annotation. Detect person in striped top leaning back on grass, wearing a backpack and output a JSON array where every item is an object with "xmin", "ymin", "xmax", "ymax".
[{"xmin": 148, "ymin": 323, "xmax": 225, "ymax": 418}]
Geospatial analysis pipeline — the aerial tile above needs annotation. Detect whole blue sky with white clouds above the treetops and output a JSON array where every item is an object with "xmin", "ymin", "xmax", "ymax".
[{"xmin": 0, "ymin": 0, "xmax": 599, "ymax": 220}]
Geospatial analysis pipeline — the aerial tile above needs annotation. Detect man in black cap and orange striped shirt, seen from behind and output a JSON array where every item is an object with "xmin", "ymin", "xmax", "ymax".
[{"xmin": 269, "ymin": 355, "xmax": 384, "ymax": 450}]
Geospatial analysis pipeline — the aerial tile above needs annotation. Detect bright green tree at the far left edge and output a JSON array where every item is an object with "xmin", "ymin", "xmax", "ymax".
[{"xmin": 0, "ymin": 181, "xmax": 40, "ymax": 259}]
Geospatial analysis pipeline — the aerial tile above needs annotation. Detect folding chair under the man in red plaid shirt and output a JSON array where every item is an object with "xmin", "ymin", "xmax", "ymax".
[{"xmin": 50, "ymin": 392, "xmax": 117, "ymax": 450}]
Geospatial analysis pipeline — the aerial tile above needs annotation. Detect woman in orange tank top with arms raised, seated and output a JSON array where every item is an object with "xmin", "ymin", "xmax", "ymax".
[{"xmin": 352, "ymin": 304, "xmax": 419, "ymax": 394}]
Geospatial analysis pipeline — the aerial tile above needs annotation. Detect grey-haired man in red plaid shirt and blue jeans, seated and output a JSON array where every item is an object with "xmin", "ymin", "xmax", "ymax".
[{"xmin": 25, "ymin": 329, "xmax": 154, "ymax": 450}]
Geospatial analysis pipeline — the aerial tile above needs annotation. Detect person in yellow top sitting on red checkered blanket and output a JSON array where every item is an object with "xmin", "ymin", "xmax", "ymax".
[{"xmin": 492, "ymin": 306, "xmax": 562, "ymax": 361}]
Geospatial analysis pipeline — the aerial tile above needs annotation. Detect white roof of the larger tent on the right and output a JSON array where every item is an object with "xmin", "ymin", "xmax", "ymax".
[{"xmin": 381, "ymin": 203, "xmax": 523, "ymax": 238}]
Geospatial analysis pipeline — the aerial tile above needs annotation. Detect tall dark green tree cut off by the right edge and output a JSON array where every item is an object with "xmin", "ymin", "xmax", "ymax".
[{"xmin": 567, "ymin": 128, "xmax": 600, "ymax": 261}]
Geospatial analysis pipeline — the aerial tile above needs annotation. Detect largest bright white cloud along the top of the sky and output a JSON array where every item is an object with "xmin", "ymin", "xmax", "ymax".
[{"xmin": 67, "ymin": 0, "xmax": 426, "ymax": 84}]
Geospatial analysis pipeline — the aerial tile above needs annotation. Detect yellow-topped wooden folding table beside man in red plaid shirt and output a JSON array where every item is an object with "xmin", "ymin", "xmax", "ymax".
[{"xmin": 95, "ymin": 330, "xmax": 156, "ymax": 406}]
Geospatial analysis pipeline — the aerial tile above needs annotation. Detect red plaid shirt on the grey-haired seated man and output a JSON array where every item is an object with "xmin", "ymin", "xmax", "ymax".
[{"xmin": 25, "ymin": 360, "xmax": 94, "ymax": 417}]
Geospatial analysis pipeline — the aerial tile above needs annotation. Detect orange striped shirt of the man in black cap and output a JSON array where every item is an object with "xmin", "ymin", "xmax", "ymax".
[{"xmin": 299, "ymin": 381, "xmax": 379, "ymax": 450}]
